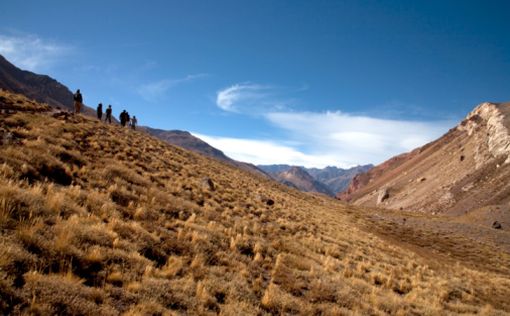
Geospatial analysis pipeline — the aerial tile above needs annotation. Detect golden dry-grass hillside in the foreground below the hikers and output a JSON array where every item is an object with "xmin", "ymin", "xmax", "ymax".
[{"xmin": 0, "ymin": 92, "xmax": 510, "ymax": 315}]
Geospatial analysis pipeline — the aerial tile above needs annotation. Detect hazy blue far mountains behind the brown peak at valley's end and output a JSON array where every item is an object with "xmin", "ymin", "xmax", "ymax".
[{"xmin": 257, "ymin": 165, "xmax": 373, "ymax": 195}]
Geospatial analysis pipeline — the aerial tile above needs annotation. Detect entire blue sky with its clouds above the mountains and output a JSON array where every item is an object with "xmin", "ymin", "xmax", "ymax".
[{"xmin": 0, "ymin": 0, "xmax": 510, "ymax": 167}]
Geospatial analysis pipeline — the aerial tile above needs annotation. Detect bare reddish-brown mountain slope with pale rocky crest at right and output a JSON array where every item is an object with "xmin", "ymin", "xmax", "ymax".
[{"xmin": 339, "ymin": 102, "xmax": 510, "ymax": 217}]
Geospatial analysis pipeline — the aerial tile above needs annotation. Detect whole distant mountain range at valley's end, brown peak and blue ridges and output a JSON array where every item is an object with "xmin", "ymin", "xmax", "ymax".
[{"xmin": 257, "ymin": 165, "xmax": 373, "ymax": 196}]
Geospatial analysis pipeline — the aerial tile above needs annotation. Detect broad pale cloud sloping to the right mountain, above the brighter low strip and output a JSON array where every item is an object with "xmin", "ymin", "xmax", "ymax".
[{"xmin": 266, "ymin": 112, "xmax": 455, "ymax": 165}]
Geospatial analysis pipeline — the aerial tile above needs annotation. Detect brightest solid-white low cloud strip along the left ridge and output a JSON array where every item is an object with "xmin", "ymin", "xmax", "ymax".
[{"xmin": 193, "ymin": 133, "xmax": 349, "ymax": 167}]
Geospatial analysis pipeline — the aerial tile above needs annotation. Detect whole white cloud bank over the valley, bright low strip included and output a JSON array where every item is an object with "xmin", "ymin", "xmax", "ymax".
[{"xmin": 194, "ymin": 108, "xmax": 455, "ymax": 168}]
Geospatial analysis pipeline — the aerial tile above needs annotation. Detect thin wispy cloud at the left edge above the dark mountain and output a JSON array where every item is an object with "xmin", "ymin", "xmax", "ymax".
[{"xmin": 0, "ymin": 34, "xmax": 73, "ymax": 71}]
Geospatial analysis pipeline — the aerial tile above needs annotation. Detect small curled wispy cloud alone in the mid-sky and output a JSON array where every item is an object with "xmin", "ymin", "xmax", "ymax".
[{"xmin": 216, "ymin": 83, "xmax": 288, "ymax": 115}]
